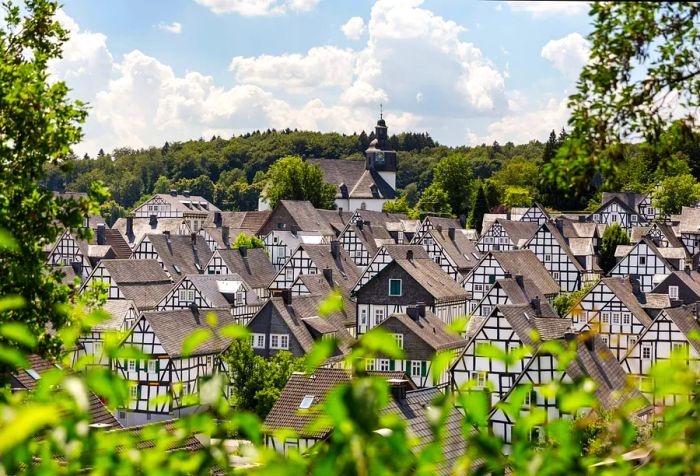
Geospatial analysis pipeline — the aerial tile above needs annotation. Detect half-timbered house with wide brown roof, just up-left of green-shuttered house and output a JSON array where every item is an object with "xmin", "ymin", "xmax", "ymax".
[{"xmin": 81, "ymin": 259, "xmax": 173, "ymax": 311}]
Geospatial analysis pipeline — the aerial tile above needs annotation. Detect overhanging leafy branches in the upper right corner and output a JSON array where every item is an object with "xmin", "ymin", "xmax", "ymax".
[{"xmin": 546, "ymin": 2, "xmax": 700, "ymax": 196}]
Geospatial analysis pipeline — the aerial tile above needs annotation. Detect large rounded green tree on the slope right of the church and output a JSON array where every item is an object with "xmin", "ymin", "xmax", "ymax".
[{"xmin": 433, "ymin": 154, "xmax": 474, "ymax": 215}]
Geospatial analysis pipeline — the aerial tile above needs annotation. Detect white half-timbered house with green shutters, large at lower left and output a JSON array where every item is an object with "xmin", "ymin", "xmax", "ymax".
[{"xmin": 111, "ymin": 308, "xmax": 234, "ymax": 426}]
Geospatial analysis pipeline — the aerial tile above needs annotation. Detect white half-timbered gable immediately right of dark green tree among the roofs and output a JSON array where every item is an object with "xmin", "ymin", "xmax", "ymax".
[{"xmin": 608, "ymin": 238, "xmax": 686, "ymax": 292}]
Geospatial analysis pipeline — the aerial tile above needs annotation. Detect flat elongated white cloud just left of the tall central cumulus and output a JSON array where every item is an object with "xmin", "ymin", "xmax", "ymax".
[{"xmin": 229, "ymin": 46, "xmax": 356, "ymax": 92}]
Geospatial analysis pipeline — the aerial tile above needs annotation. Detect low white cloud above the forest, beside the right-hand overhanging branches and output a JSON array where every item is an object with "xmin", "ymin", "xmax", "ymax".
[{"xmin": 466, "ymin": 98, "xmax": 569, "ymax": 145}]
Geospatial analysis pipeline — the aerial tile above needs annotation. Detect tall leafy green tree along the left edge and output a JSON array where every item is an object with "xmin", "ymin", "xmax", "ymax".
[{"xmin": 0, "ymin": 1, "xmax": 105, "ymax": 356}]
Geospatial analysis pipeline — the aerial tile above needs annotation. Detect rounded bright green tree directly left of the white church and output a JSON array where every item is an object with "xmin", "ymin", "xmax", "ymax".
[{"xmin": 262, "ymin": 156, "xmax": 336, "ymax": 209}]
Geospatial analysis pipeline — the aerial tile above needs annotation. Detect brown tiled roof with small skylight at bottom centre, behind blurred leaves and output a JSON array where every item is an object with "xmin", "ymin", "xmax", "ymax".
[{"xmin": 263, "ymin": 368, "xmax": 350, "ymax": 439}]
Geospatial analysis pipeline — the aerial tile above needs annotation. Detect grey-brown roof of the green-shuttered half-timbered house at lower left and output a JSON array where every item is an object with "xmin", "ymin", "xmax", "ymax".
[{"xmin": 142, "ymin": 309, "xmax": 235, "ymax": 358}]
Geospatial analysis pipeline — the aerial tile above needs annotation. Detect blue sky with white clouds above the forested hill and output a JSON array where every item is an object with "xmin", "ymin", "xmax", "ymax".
[{"xmin": 52, "ymin": 0, "xmax": 590, "ymax": 154}]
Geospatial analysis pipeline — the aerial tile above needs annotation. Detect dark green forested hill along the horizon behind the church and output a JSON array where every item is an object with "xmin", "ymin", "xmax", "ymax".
[{"xmin": 46, "ymin": 130, "xmax": 544, "ymax": 214}]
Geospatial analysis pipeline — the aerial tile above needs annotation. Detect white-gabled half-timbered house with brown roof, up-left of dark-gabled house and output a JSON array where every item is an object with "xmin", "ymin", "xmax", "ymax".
[{"xmin": 270, "ymin": 244, "xmax": 360, "ymax": 294}]
